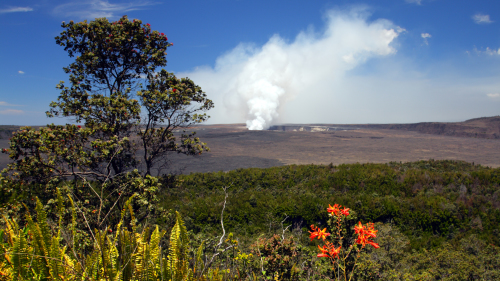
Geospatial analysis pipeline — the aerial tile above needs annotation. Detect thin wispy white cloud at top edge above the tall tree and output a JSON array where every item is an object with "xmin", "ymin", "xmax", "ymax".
[{"xmin": 53, "ymin": 0, "xmax": 156, "ymax": 20}]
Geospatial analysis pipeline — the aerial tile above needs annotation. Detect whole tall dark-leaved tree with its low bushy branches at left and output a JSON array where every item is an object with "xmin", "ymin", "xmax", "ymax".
[{"xmin": 0, "ymin": 16, "xmax": 213, "ymax": 234}]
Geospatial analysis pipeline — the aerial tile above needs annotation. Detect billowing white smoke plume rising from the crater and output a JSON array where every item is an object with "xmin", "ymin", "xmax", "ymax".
[{"xmin": 179, "ymin": 9, "xmax": 404, "ymax": 130}]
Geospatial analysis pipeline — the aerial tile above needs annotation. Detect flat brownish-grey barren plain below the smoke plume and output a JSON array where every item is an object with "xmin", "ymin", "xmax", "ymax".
[{"xmin": 0, "ymin": 117, "xmax": 500, "ymax": 174}]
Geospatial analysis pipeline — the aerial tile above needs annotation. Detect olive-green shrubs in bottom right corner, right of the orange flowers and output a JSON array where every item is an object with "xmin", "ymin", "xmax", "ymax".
[{"xmin": 356, "ymin": 224, "xmax": 500, "ymax": 280}]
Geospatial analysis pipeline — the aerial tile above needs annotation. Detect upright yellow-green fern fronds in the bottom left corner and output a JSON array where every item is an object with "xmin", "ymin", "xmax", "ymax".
[{"xmin": 0, "ymin": 196, "xmax": 204, "ymax": 281}]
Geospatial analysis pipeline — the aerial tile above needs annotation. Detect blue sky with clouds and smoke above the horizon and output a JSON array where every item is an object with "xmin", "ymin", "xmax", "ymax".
[{"xmin": 0, "ymin": 0, "xmax": 500, "ymax": 130}]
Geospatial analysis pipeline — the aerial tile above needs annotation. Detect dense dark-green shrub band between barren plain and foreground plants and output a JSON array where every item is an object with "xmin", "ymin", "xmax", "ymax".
[{"xmin": 162, "ymin": 161, "xmax": 500, "ymax": 249}]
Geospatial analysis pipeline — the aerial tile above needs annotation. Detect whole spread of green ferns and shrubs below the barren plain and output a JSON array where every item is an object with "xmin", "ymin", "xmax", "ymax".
[{"xmin": 0, "ymin": 161, "xmax": 500, "ymax": 280}]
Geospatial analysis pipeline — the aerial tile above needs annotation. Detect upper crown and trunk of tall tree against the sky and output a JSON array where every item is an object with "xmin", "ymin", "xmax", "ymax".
[{"xmin": 47, "ymin": 16, "xmax": 213, "ymax": 175}]
